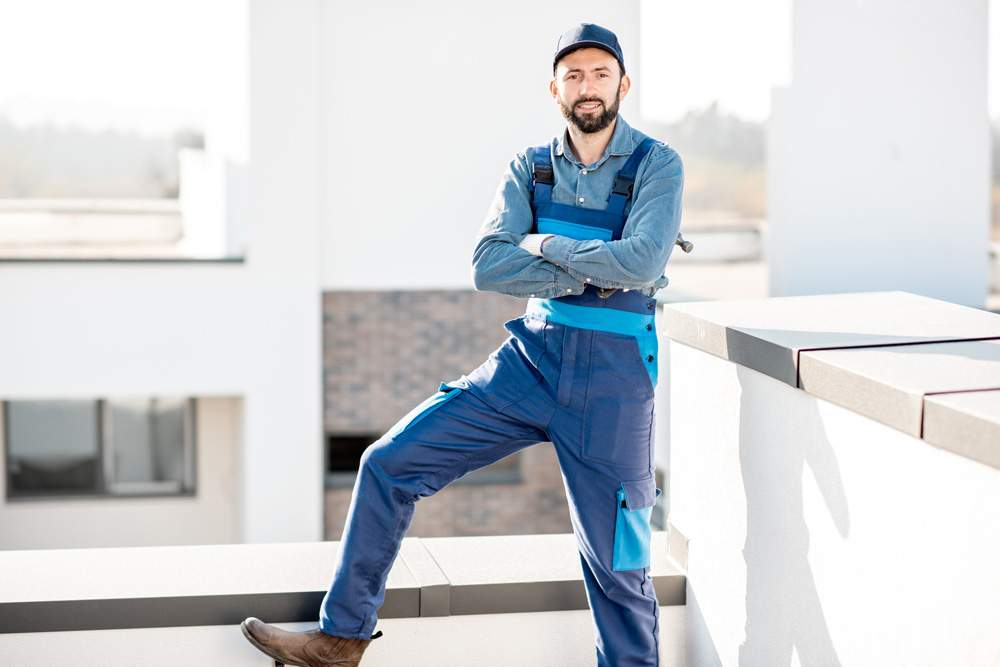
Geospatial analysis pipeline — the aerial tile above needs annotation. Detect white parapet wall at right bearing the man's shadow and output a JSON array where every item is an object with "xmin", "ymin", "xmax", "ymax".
[{"xmin": 668, "ymin": 342, "xmax": 1000, "ymax": 667}]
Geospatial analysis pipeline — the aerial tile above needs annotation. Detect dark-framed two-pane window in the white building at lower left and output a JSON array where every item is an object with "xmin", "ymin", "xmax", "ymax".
[{"xmin": 3, "ymin": 398, "xmax": 195, "ymax": 499}]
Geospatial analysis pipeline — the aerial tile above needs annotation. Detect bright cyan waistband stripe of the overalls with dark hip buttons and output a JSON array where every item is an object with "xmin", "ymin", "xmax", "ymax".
[{"xmin": 525, "ymin": 297, "xmax": 659, "ymax": 387}]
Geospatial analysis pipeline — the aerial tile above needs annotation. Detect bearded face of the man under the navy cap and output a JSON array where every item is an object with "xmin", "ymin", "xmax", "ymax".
[{"xmin": 549, "ymin": 47, "xmax": 630, "ymax": 133}]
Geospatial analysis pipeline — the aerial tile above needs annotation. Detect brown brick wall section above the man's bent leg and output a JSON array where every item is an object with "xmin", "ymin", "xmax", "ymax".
[{"xmin": 323, "ymin": 290, "xmax": 527, "ymax": 434}]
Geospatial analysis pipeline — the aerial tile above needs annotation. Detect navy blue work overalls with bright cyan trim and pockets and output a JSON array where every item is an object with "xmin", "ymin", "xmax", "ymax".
[{"xmin": 319, "ymin": 139, "xmax": 661, "ymax": 667}]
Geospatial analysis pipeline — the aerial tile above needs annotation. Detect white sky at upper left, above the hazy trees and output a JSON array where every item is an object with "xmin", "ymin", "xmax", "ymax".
[{"xmin": 0, "ymin": 0, "xmax": 245, "ymax": 134}]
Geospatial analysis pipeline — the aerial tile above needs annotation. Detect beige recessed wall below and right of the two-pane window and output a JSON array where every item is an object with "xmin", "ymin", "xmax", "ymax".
[{"xmin": 0, "ymin": 397, "xmax": 243, "ymax": 549}]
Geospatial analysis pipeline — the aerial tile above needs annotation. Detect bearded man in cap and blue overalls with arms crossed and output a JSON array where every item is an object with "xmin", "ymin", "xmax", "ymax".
[{"xmin": 242, "ymin": 23, "xmax": 683, "ymax": 667}]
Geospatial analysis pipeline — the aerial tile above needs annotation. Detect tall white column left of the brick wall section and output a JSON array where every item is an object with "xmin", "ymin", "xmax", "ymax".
[{"xmin": 242, "ymin": 0, "xmax": 323, "ymax": 542}]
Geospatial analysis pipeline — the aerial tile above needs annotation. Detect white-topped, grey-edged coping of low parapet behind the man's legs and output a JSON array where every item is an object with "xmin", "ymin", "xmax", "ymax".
[{"xmin": 0, "ymin": 531, "xmax": 685, "ymax": 633}]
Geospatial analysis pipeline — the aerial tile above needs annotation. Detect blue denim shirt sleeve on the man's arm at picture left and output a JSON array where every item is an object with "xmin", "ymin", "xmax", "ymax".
[{"xmin": 472, "ymin": 151, "xmax": 585, "ymax": 298}]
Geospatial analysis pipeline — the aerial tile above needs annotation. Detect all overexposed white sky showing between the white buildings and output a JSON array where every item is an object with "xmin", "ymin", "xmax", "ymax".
[{"xmin": 0, "ymin": 0, "xmax": 1000, "ymax": 134}]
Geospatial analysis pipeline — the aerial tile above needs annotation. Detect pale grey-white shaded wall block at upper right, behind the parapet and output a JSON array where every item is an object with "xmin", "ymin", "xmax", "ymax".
[{"xmin": 765, "ymin": 0, "xmax": 990, "ymax": 307}]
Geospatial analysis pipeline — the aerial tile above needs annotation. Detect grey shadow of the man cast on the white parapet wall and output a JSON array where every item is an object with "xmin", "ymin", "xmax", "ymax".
[{"xmin": 732, "ymin": 366, "xmax": 850, "ymax": 667}]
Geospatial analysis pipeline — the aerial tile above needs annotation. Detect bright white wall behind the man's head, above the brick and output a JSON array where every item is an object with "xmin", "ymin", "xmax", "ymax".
[{"xmin": 321, "ymin": 0, "xmax": 642, "ymax": 289}]
